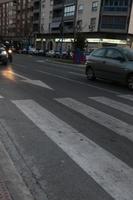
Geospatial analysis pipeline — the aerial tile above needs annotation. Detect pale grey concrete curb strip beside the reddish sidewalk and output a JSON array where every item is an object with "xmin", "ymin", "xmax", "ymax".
[{"xmin": 0, "ymin": 141, "xmax": 33, "ymax": 200}]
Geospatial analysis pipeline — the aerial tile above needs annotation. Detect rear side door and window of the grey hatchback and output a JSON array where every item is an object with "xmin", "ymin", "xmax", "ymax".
[{"xmin": 89, "ymin": 48, "xmax": 106, "ymax": 77}]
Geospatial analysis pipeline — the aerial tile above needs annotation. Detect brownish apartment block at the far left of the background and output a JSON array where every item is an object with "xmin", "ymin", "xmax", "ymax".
[{"xmin": 0, "ymin": 0, "xmax": 33, "ymax": 45}]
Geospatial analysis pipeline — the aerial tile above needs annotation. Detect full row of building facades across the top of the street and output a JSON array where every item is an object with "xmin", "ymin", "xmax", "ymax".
[{"xmin": 0, "ymin": 0, "xmax": 133, "ymax": 50}]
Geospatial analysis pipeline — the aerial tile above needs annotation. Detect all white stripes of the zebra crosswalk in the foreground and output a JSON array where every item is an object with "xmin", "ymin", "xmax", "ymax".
[{"xmin": 0, "ymin": 95, "xmax": 133, "ymax": 200}]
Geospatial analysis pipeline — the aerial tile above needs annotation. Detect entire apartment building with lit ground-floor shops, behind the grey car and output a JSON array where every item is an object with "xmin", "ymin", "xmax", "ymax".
[{"xmin": 37, "ymin": 0, "xmax": 133, "ymax": 49}]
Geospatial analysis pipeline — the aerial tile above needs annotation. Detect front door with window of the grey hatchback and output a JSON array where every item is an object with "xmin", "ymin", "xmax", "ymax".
[{"xmin": 103, "ymin": 48, "xmax": 126, "ymax": 81}]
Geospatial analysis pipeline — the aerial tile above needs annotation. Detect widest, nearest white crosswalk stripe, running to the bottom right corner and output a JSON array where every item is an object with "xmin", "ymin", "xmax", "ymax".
[{"xmin": 12, "ymin": 100, "xmax": 133, "ymax": 200}]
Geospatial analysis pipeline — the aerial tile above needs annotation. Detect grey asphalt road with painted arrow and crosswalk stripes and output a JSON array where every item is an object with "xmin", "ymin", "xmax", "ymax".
[{"xmin": 0, "ymin": 55, "xmax": 133, "ymax": 200}]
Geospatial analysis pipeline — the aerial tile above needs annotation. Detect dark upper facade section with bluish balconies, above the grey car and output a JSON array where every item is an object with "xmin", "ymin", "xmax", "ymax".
[{"xmin": 99, "ymin": 0, "xmax": 133, "ymax": 37}]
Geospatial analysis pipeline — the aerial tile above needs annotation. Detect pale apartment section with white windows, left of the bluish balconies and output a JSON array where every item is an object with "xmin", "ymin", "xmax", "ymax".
[{"xmin": 37, "ymin": 0, "xmax": 101, "ymax": 49}]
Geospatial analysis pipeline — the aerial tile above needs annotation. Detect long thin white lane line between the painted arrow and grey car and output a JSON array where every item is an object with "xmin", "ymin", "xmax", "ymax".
[{"xmin": 36, "ymin": 70, "xmax": 120, "ymax": 95}]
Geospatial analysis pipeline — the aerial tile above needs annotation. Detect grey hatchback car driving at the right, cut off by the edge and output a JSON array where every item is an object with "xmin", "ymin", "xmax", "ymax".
[{"xmin": 86, "ymin": 47, "xmax": 133, "ymax": 90}]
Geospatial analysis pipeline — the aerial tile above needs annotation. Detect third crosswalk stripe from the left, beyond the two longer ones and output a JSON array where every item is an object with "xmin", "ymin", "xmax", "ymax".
[{"xmin": 89, "ymin": 96, "xmax": 133, "ymax": 115}]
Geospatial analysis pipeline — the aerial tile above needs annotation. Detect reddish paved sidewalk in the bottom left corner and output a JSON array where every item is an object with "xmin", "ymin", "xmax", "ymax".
[{"xmin": 0, "ymin": 167, "xmax": 12, "ymax": 200}]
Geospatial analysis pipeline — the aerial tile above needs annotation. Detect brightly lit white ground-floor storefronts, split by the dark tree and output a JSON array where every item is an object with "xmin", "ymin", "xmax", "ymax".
[{"xmin": 35, "ymin": 38, "xmax": 132, "ymax": 51}]
